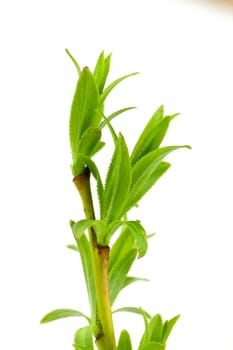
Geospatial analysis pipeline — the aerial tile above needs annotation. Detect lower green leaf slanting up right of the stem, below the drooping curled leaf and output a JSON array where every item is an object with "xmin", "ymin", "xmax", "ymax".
[{"xmin": 109, "ymin": 249, "xmax": 137, "ymax": 304}]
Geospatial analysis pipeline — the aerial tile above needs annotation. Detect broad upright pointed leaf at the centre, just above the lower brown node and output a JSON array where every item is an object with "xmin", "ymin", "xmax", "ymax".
[{"xmin": 101, "ymin": 134, "xmax": 131, "ymax": 224}]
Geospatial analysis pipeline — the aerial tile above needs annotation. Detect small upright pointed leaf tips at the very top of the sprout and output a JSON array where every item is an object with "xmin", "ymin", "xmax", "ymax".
[{"xmin": 93, "ymin": 51, "xmax": 111, "ymax": 94}]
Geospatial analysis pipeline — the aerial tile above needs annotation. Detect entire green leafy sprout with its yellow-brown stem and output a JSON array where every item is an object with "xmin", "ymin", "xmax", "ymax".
[{"xmin": 41, "ymin": 50, "xmax": 190, "ymax": 350}]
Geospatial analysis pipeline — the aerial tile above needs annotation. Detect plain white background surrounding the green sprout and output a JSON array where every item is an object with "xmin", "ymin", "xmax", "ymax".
[{"xmin": 0, "ymin": 0, "xmax": 233, "ymax": 350}]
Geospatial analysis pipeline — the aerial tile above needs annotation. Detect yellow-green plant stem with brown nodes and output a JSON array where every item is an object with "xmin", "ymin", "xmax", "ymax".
[{"xmin": 73, "ymin": 168, "xmax": 116, "ymax": 350}]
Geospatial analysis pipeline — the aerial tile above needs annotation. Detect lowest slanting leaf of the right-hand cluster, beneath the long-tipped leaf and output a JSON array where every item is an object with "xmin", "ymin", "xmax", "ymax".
[{"xmin": 125, "ymin": 162, "xmax": 171, "ymax": 211}]
